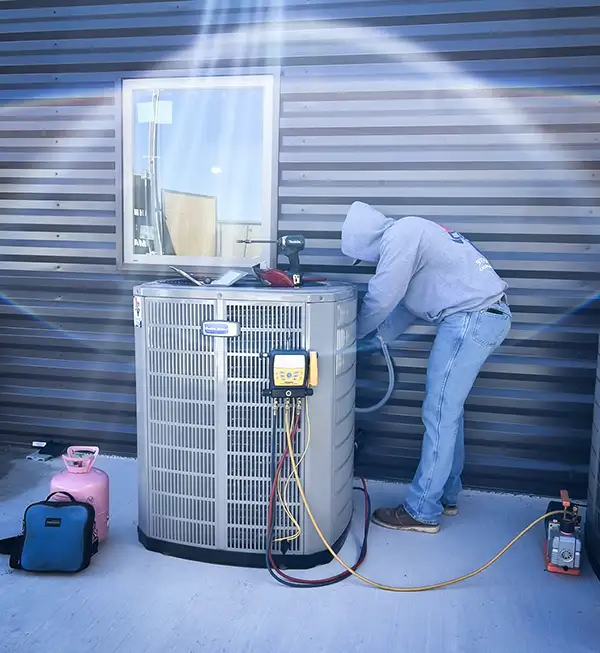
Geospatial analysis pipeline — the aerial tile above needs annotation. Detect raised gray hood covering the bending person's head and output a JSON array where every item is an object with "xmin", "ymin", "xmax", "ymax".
[{"xmin": 342, "ymin": 202, "xmax": 395, "ymax": 263}]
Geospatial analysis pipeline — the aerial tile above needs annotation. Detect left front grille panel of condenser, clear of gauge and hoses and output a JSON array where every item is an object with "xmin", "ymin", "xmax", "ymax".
[{"xmin": 146, "ymin": 300, "xmax": 216, "ymax": 547}]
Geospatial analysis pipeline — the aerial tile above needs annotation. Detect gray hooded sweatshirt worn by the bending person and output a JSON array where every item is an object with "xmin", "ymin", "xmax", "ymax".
[{"xmin": 342, "ymin": 202, "xmax": 507, "ymax": 342}]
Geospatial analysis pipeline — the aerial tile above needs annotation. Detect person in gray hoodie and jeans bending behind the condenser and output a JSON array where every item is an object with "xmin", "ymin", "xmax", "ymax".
[{"xmin": 342, "ymin": 202, "xmax": 512, "ymax": 533}]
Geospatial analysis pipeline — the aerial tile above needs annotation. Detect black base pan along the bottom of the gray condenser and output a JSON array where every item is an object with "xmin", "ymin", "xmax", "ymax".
[{"xmin": 138, "ymin": 523, "xmax": 350, "ymax": 569}]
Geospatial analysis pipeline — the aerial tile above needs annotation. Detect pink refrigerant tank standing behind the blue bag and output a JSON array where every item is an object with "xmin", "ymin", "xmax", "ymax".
[{"xmin": 50, "ymin": 447, "xmax": 109, "ymax": 542}]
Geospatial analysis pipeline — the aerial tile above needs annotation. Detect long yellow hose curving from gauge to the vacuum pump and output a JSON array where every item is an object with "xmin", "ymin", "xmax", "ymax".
[{"xmin": 285, "ymin": 399, "xmax": 563, "ymax": 592}]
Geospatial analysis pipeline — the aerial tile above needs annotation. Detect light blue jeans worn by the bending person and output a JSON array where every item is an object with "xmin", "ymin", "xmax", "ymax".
[{"xmin": 403, "ymin": 302, "xmax": 512, "ymax": 524}]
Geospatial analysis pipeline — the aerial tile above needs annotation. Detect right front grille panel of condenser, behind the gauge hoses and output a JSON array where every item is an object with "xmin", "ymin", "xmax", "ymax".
[{"xmin": 226, "ymin": 302, "xmax": 304, "ymax": 552}]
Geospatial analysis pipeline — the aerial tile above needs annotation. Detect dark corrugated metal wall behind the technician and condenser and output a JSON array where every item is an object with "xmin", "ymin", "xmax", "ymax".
[{"xmin": 0, "ymin": 0, "xmax": 600, "ymax": 496}]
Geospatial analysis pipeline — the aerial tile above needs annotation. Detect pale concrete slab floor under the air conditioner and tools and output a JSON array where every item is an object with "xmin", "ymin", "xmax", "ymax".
[{"xmin": 0, "ymin": 451, "xmax": 600, "ymax": 653}]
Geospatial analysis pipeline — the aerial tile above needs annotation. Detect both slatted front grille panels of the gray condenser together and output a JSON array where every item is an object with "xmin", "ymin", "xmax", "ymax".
[{"xmin": 146, "ymin": 299, "xmax": 304, "ymax": 552}]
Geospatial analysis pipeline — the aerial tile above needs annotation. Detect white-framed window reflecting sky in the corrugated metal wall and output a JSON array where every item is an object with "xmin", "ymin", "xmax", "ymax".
[{"xmin": 123, "ymin": 75, "xmax": 277, "ymax": 267}]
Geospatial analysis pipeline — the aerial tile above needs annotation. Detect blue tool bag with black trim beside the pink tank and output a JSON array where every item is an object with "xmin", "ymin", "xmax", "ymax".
[{"xmin": 0, "ymin": 492, "xmax": 98, "ymax": 573}]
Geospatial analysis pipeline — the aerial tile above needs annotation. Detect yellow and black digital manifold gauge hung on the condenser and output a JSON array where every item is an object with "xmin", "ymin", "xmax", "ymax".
[{"xmin": 265, "ymin": 349, "xmax": 318, "ymax": 398}]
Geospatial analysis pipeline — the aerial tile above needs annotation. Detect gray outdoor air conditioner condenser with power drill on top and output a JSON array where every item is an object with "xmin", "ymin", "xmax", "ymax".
[{"xmin": 133, "ymin": 279, "xmax": 356, "ymax": 569}]
